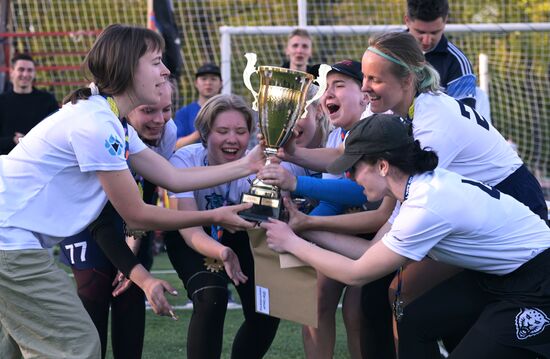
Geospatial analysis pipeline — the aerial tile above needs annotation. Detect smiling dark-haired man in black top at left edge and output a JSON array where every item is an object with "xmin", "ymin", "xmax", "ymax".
[{"xmin": 0, "ymin": 54, "xmax": 59, "ymax": 154}]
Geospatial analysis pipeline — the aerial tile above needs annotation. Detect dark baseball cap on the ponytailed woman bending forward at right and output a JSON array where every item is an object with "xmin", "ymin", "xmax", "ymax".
[{"xmin": 327, "ymin": 114, "xmax": 414, "ymax": 173}]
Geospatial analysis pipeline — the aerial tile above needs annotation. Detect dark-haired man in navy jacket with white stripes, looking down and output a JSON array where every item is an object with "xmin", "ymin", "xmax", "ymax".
[{"xmin": 405, "ymin": 0, "xmax": 476, "ymax": 108}]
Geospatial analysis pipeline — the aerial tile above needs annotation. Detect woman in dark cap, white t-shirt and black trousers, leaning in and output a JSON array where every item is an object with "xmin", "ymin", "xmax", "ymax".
[{"xmin": 262, "ymin": 115, "xmax": 550, "ymax": 359}]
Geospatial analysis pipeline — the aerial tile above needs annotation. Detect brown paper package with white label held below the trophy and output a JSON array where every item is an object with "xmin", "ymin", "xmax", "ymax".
[{"xmin": 248, "ymin": 228, "xmax": 318, "ymax": 328}]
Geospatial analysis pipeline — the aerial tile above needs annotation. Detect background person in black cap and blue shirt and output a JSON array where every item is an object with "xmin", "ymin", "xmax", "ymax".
[{"xmin": 174, "ymin": 63, "xmax": 222, "ymax": 149}]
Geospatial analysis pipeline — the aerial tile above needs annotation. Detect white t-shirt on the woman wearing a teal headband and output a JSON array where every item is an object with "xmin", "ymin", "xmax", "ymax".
[{"xmin": 412, "ymin": 93, "xmax": 523, "ymax": 186}]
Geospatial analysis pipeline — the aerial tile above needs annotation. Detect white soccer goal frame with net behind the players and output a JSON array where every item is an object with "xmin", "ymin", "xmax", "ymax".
[{"xmin": 219, "ymin": 23, "xmax": 550, "ymax": 190}]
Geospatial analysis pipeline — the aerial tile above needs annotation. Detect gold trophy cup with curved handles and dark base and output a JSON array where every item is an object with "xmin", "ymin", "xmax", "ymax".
[{"xmin": 239, "ymin": 53, "xmax": 331, "ymax": 222}]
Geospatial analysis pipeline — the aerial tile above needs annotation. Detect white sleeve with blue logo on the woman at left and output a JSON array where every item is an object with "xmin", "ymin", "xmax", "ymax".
[{"xmin": 69, "ymin": 112, "xmax": 128, "ymax": 172}]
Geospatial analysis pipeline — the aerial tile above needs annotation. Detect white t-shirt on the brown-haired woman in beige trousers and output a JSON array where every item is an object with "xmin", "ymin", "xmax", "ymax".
[{"xmin": 0, "ymin": 96, "xmax": 146, "ymax": 250}]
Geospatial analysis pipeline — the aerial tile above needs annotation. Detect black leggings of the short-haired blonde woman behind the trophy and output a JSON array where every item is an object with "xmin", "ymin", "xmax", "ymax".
[{"xmin": 165, "ymin": 232, "xmax": 279, "ymax": 359}]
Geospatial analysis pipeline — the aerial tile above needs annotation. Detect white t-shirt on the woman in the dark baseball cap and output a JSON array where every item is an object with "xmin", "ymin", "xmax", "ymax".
[{"xmin": 382, "ymin": 169, "xmax": 550, "ymax": 275}]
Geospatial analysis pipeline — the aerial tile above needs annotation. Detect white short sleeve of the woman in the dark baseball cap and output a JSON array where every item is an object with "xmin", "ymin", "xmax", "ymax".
[{"xmin": 382, "ymin": 205, "xmax": 452, "ymax": 261}]
